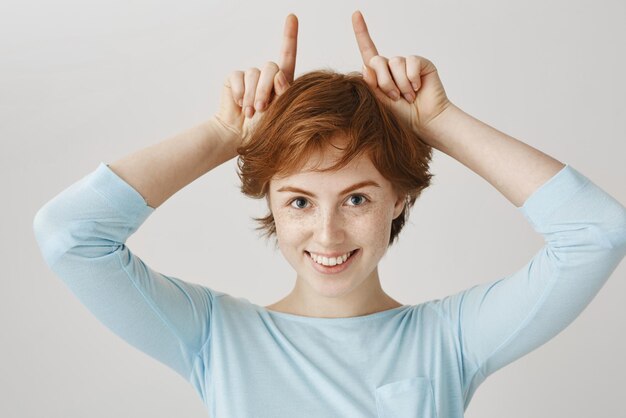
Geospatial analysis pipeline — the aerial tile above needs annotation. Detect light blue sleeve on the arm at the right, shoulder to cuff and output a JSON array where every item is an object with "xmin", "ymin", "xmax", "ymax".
[{"xmin": 435, "ymin": 165, "xmax": 626, "ymax": 405}]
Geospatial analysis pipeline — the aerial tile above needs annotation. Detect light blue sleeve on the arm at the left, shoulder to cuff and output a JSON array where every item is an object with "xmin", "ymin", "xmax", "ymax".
[{"xmin": 33, "ymin": 163, "xmax": 213, "ymax": 380}]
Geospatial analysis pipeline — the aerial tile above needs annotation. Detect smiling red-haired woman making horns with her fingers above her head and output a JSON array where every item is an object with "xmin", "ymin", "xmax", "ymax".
[{"xmin": 34, "ymin": 12, "xmax": 626, "ymax": 418}]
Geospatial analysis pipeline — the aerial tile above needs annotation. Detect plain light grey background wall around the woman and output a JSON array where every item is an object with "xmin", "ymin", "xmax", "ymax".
[{"xmin": 0, "ymin": 0, "xmax": 626, "ymax": 418}]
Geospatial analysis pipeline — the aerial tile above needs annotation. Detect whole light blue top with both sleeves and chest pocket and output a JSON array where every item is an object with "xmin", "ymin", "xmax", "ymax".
[{"xmin": 33, "ymin": 163, "xmax": 626, "ymax": 418}]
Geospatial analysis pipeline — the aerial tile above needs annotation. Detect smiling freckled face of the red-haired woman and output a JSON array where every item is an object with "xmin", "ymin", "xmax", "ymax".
[{"xmin": 269, "ymin": 138, "xmax": 404, "ymax": 298}]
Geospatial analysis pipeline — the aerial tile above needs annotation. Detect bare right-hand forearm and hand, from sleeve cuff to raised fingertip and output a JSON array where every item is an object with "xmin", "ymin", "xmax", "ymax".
[{"xmin": 352, "ymin": 12, "xmax": 564, "ymax": 207}]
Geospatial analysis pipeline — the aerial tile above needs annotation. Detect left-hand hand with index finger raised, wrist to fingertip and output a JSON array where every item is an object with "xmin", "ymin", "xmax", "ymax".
[{"xmin": 216, "ymin": 14, "xmax": 298, "ymax": 145}]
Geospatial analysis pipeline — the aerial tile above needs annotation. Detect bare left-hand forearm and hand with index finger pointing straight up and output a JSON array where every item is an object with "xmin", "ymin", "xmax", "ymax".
[{"xmin": 109, "ymin": 14, "xmax": 298, "ymax": 208}]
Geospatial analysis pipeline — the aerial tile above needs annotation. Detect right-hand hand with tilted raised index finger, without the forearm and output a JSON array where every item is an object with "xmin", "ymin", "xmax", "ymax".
[{"xmin": 352, "ymin": 11, "xmax": 450, "ymax": 134}]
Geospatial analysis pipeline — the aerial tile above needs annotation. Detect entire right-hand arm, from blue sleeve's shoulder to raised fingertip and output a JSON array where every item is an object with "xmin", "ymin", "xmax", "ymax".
[{"xmin": 352, "ymin": 8, "xmax": 626, "ymax": 406}]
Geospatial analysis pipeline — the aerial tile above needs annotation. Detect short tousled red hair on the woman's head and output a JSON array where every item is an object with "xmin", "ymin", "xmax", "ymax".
[{"xmin": 237, "ymin": 70, "xmax": 433, "ymax": 245}]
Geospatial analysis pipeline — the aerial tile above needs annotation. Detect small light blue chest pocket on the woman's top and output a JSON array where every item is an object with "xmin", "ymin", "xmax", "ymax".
[{"xmin": 375, "ymin": 377, "xmax": 437, "ymax": 418}]
